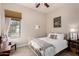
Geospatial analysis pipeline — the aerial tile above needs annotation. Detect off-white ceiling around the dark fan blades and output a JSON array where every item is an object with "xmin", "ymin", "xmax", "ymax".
[{"xmin": 19, "ymin": 3, "xmax": 63, "ymax": 13}]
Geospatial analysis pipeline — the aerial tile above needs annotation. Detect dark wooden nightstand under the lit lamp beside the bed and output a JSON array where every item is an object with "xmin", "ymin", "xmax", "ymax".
[{"xmin": 67, "ymin": 40, "xmax": 79, "ymax": 55}]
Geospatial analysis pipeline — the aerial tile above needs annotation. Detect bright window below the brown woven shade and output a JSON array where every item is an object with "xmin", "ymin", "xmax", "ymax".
[{"xmin": 8, "ymin": 18, "xmax": 21, "ymax": 38}]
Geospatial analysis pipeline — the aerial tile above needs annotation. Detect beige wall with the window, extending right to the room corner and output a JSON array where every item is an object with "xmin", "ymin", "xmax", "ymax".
[{"xmin": 3, "ymin": 4, "xmax": 46, "ymax": 46}]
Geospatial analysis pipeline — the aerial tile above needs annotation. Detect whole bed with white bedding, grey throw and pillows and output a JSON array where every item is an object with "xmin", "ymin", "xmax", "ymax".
[{"xmin": 29, "ymin": 33, "xmax": 68, "ymax": 56}]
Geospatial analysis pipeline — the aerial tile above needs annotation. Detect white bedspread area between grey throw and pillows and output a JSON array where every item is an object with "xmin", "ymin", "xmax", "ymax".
[{"xmin": 39, "ymin": 37, "xmax": 67, "ymax": 53}]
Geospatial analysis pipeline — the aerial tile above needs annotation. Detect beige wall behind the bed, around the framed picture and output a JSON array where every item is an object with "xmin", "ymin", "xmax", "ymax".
[{"xmin": 47, "ymin": 4, "xmax": 79, "ymax": 33}]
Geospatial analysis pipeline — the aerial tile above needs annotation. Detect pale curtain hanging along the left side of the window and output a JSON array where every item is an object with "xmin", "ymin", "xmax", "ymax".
[{"xmin": 1, "ymin": 17, "xmax": 11, "ymax": 50}]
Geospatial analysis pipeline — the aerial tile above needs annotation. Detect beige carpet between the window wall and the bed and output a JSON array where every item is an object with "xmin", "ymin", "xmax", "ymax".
[{"xmin": 11, "ymin": 47, "xmax": 36, "ymax": 56}]
